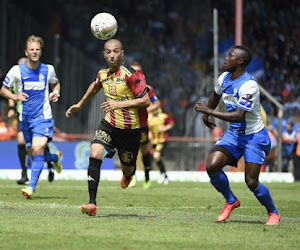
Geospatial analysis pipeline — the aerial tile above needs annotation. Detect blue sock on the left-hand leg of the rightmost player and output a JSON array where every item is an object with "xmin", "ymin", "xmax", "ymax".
[{"xmin": 208, "ymin": 171, "xmax": 236, "ymax": 204}]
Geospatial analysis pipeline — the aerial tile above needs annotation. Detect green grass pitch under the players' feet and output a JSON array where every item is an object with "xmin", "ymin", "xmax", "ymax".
[{"xmin": 0, "ymin": 180, "xmax": 300, "ymax": 249}]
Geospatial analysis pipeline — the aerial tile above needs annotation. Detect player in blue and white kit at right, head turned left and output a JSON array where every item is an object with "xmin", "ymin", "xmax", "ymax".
[{"xmin": 195, "ymin": 46, "xmax": 280, "ymax": 225}]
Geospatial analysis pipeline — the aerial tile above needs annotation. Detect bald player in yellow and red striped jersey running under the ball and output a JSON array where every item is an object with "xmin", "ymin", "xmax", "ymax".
[{"xmin": 66, "ymin": 39, "xmax": 150, "ymax": 216}]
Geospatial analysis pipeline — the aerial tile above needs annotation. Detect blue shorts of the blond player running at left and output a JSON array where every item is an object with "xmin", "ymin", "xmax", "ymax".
[{"xmin": 20, "ymin": 119, "xmax": 54, "ymax": 148}]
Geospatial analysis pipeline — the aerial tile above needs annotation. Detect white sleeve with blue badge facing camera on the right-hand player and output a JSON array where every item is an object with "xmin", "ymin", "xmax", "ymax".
[{"xmin": 236, "ymin": 80, "xmax": 259, "ymax": 111}]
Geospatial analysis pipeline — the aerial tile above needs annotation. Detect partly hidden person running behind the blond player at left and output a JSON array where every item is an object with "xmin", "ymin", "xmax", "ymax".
[{"xmin": 7, "ymin": 57, "xmax": 54, "ymax": 185}]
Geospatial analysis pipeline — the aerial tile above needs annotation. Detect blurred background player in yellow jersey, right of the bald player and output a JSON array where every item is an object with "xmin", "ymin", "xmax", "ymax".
[{"xmin": 148, "ymin": 109, "xmax": 174, "ymax": 185}]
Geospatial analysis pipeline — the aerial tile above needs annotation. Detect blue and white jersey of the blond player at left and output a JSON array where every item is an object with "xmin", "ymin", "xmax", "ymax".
[{"xmin": 3, "ymin": 63, "xmax": 58, "ymax": 122}]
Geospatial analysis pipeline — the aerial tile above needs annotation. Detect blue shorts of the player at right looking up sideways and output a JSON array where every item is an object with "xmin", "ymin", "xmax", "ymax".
[{"xmin": 215, "ymin": 128, "xmax": 271, "ymax": 165}]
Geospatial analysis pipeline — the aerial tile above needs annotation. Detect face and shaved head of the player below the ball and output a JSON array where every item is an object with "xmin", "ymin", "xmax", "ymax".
[{"xmin": 103, "ymin": 41, "xmax": 124, "ymax": 70}]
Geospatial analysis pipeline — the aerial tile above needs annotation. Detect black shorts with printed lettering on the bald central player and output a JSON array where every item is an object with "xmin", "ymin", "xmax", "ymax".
[{"xmin": 91, "ymin": 119, "xmax": 141, "ymax": 166}]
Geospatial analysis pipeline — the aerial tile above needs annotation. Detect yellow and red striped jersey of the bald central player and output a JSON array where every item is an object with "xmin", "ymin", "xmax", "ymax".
[{"xmin": 96, "ymin": 64, "xmax": 149, "ymax": 129}]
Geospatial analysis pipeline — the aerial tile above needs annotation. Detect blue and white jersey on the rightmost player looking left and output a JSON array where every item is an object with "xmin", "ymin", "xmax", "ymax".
[{"xmin": 215, "ymin": 72, "xmax": 264, "ymax": 135}]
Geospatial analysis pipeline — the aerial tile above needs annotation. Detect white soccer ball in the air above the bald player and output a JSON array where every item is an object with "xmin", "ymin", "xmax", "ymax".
[{"xmin": 91, "ymin": 12, "xmax": 118, "ymax": 40}]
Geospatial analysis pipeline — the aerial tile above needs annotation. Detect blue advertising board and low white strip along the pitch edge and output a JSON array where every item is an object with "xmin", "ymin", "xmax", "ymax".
[{"xmin": 0, "ymin": 141, "xmax": 294, "ymax": 183}]
